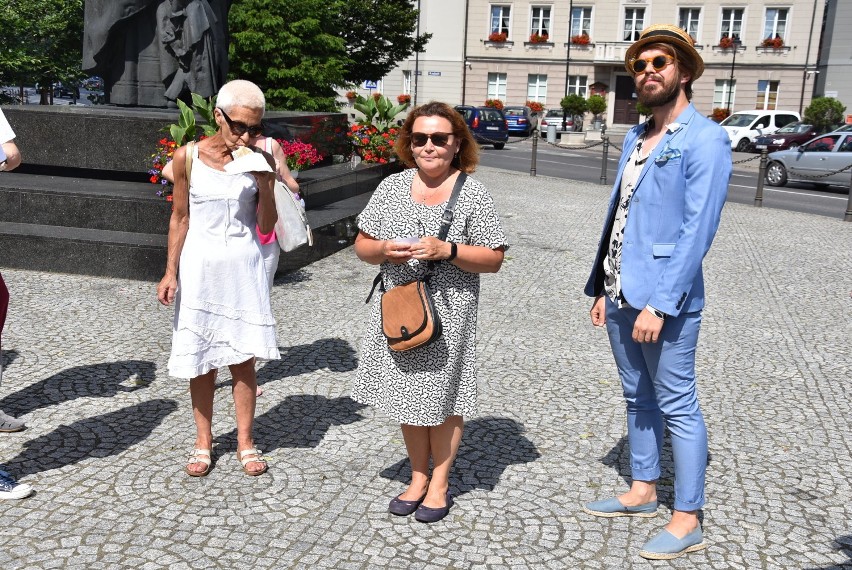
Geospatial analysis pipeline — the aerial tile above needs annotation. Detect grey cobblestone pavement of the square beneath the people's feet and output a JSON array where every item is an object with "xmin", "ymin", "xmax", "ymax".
[{"xmin": 0, "ymin": 168, "xmax": 852, "ymax": 569}]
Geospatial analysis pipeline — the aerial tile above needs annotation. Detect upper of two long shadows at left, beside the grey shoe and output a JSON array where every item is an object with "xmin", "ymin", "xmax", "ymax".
[{"xmin": 0, "ymin": 355, "xmax": 157, "ymax": 416}]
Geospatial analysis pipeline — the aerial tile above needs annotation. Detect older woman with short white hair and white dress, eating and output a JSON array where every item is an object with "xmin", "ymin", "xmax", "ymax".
[{"xmin": 157, "ymin": 80, "xmax": 280, "ymax": 477}]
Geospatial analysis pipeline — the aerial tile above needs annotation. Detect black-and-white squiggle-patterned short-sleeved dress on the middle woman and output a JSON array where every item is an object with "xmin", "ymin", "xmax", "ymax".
[{"xmin": 352, "ymin": 168, "xmax": 508, "ymax": 426}]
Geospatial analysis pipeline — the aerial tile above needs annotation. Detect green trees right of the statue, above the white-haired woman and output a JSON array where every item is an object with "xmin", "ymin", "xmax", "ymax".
[{"xmin": 228, "ymin": 0, "xmax": 430, "ymax": 111}]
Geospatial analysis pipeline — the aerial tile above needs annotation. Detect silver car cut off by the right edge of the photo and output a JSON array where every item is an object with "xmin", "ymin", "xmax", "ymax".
[{"xmin": 766, "ymin": 130, "xmax": 852, "ymax": 187}]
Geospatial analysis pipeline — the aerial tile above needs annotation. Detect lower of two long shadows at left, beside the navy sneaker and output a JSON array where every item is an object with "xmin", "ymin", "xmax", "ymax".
[{"xmin": 4, "ymin": 399, "xmax": 177, "ymax": 477}]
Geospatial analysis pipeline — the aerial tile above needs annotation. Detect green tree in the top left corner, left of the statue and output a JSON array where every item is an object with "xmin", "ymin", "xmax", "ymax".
[{"xmin": 0, "ymin": 0, "xmax": 83, "ymax": 104}]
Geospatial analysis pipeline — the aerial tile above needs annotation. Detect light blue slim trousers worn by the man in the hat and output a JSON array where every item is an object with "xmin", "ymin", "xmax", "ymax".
[{"xmin": 606, "ymin": 298, "xmax": 707, "ymax": 511}]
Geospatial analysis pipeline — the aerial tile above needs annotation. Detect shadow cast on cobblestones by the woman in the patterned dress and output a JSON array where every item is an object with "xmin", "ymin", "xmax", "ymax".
[{"xmin": 379, "ymin": 417, "xmax": 541, "ymax": 497}]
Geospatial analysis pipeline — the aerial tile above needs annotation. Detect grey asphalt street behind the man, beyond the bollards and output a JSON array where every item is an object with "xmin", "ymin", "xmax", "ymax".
[{"xmin": 481, "ymin": 138, "xmax": 849, "ymax": 219}]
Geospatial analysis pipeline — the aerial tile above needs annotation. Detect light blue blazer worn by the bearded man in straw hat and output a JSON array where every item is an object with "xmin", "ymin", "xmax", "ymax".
[{"xmin": 585, "ymin": 103, "xmax": 732, "ymax": 315}]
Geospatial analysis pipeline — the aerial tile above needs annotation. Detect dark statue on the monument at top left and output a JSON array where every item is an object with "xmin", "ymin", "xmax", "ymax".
[{"xmin": 83, "ymin": 0, "xmax": 232, "ymax": 107}]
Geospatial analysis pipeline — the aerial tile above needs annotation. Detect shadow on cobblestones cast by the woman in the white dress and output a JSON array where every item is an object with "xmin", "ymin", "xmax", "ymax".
[{"xmin": 213, "ymin": 394, "xmax": 366, "ymax": 455}]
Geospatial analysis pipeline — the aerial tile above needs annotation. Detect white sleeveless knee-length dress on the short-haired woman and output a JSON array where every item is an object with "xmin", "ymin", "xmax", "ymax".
[{"xmin": 168, "ymin": 147, "xmax": 281, "ymax": 378}]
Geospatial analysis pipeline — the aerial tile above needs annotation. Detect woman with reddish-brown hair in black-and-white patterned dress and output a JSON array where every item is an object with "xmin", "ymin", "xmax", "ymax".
[{"xmin": 352, "ymin": 102, "xmax": 508, "ymax": 522}]
